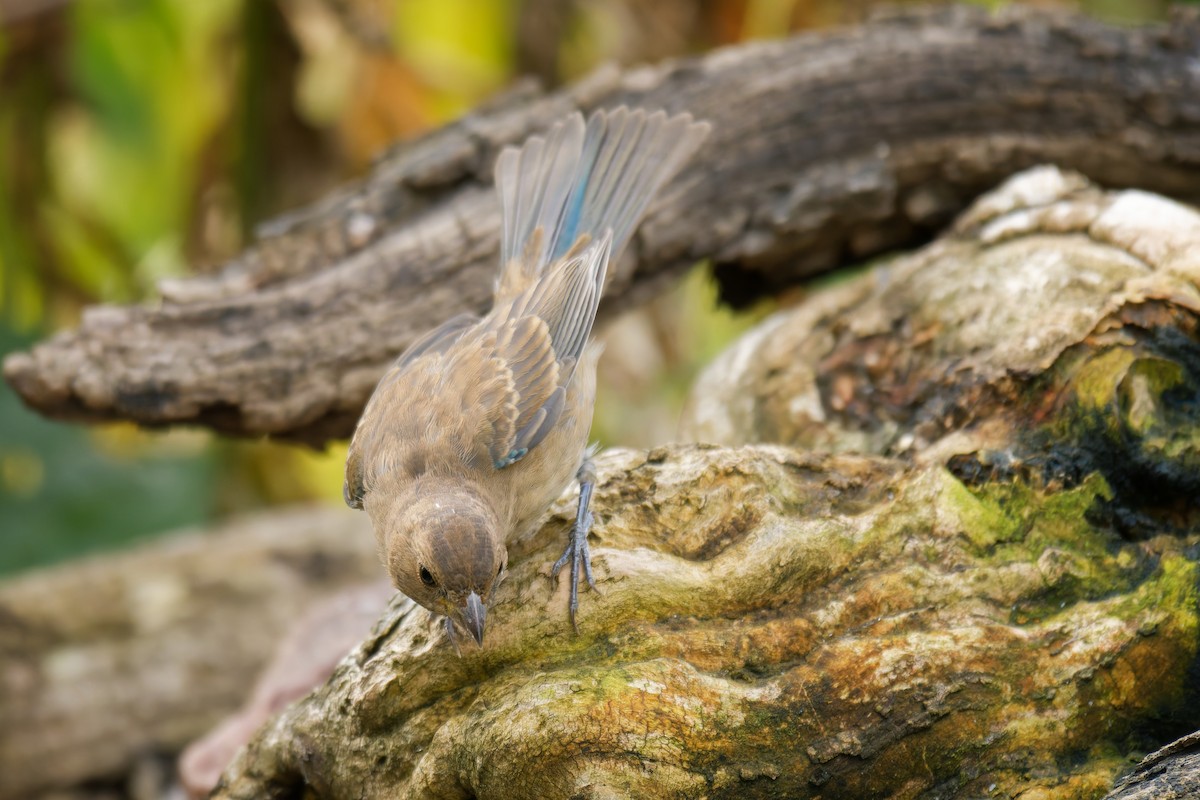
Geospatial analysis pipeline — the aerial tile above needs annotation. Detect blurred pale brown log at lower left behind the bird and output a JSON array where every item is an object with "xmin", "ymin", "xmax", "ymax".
[{"xmin": 0, "ymin": 509, "xmax": 385, "ymax": 800}]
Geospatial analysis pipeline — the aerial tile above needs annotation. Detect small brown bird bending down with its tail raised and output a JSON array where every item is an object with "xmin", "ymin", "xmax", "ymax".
[{"xmin": 343, "ymin": 106, "xmax": 710, "ymax": 649}]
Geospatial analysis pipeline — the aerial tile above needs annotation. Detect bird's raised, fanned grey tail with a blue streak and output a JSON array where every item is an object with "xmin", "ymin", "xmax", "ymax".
[{"xmin": 496, "ymin": 107, "xmax": 709, "ymax": 305}]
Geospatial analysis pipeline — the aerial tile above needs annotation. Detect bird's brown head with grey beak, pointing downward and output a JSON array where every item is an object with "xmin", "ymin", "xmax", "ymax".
[{"xmin": 365, "ymin": 480, "xmax": 508, "ymax": 644}]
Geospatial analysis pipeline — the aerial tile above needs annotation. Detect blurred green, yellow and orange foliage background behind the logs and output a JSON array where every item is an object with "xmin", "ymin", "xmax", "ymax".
[{"xmin": 0, "ymin": 0, "xmax": 1166, "ymax": 576}]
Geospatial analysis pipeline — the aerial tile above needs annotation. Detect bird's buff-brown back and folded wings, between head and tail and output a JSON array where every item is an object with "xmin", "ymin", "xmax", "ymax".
[{"xmin": 342, "ymin": 235, "xmax": 611, "ymax": 509}]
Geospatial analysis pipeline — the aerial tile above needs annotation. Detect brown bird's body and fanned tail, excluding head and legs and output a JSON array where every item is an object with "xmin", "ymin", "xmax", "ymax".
[{"xmin": 346, "ymin": 108, "xmax": 708, "ymax": 534}]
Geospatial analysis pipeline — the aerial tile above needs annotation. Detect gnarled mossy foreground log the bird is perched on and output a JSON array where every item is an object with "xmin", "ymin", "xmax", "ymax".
[{"xmin": 216, "ymin": 446, "xmax": 1200, "ymax": 799}]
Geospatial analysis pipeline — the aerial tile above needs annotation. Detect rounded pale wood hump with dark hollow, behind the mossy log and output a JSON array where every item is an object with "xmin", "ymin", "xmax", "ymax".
[{"xmin": 682, "ymin": 168, "xmax": 1200, "ymax": 535}]
